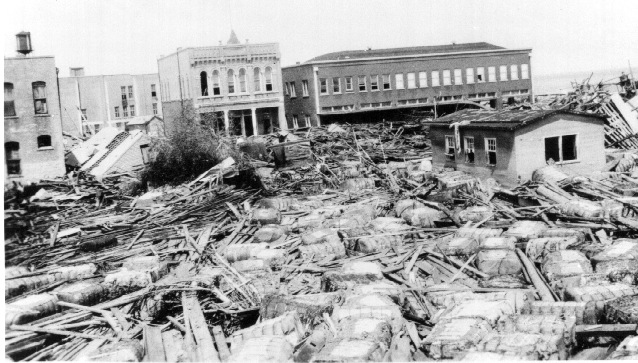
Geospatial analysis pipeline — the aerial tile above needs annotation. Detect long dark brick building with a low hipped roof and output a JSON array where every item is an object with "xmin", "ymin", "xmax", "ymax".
[{"xmin": 282, "ymin": 43, "xmax": 532, "ymax": 128}]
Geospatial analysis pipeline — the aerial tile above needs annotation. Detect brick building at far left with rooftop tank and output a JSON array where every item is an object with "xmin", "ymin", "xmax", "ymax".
[{"xmin": 4, "ymin": 32, "xmax": 66, "ymax": 184}]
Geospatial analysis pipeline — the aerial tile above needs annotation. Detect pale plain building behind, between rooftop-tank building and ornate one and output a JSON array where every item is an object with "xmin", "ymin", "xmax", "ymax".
[{"xmin": 60, "ymin": 68, "xmax": 162, "ymax": 136}]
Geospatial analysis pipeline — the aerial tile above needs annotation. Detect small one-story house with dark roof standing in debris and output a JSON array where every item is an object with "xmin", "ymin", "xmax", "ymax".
[{"xmin": 430, "ymin": 109, "xmax": 605, "ymax": 186}]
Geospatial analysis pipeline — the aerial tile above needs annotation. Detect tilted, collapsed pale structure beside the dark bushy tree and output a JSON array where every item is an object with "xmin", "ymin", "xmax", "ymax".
[{"xmin": 66, "ymin": 127, "xmax": 150, "ymax": 180}]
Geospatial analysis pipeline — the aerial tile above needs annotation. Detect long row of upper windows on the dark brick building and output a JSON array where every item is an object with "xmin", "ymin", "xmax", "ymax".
[{"xmin": 285, "ymin": 64, "xmax": 529, "ymax": 98}]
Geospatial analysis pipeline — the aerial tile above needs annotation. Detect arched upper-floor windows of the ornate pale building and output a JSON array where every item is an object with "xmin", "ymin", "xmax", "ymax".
[{"xmin": 199, "ymin": 67, "xmax": 273, "ymax": 97}]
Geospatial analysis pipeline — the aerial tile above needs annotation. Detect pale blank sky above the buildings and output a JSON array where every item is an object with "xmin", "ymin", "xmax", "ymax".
[{"xmin": 3, "ymin": 0, "xmax": 638, "ymax": 76}]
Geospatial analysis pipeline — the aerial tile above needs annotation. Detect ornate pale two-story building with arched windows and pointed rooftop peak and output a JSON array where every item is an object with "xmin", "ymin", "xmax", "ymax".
[{"xmin": 157, "ymin": 32, "xmax": 286, "ymax": 136}]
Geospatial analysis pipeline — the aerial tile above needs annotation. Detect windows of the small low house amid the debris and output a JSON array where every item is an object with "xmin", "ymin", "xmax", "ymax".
[{"xmin": 445, "ymin": 135, "xmax": 578, "ymax": 165}]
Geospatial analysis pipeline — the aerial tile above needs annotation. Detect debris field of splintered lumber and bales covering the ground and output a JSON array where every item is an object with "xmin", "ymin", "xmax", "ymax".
[{"xmin": 5, "ymin": 83, "xmax": 638, "ymax": 362}]
